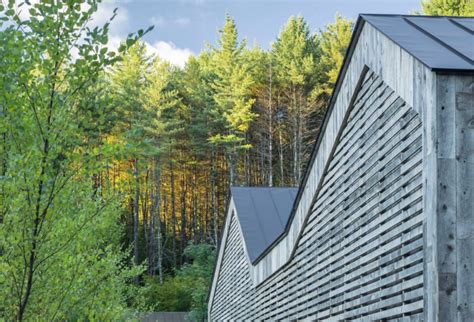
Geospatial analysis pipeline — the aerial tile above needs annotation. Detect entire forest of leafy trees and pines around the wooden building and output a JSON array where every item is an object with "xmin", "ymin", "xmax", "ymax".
[{"xmin": 0, "ymin": 0, "xmax": 474, "ymax": 321}]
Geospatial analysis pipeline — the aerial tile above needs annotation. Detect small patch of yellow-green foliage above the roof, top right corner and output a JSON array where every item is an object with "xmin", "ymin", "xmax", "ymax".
[{"xmin": 421, "ymin": 0, "xmax": 474, "ymax": 16}]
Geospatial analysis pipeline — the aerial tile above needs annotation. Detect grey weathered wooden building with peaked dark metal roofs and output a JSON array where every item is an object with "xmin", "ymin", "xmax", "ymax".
[{"xmin": 208, "ymin": 15, "xmax": 474, "ymax": 321}]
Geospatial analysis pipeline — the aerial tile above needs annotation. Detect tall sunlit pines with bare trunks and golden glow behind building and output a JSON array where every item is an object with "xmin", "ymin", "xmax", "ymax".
[{"xmin": 110, "ymin": 11, "xmax": 352, "ymax": 279}]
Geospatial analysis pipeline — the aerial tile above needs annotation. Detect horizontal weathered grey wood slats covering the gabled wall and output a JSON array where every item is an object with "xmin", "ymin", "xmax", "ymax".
[{"xmin": 210, "ymin": 71, "xmax": 424, "ymax": 321}]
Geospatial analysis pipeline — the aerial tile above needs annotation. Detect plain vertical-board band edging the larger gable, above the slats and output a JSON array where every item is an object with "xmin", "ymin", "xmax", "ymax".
[{"xmin": 251, "ymin": 23, "xmax": 428, "ymax": 286}]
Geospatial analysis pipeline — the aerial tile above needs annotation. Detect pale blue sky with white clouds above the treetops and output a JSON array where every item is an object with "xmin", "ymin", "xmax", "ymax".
[{"xmin": 96, "ymin": 0, "xmax": 420, "ymax": 66}]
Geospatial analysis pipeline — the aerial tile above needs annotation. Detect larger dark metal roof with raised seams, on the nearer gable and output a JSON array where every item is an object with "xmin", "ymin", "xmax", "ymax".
[{"xmin": 361, "ymin": 14, "xmax": 474, "ymax": 71}]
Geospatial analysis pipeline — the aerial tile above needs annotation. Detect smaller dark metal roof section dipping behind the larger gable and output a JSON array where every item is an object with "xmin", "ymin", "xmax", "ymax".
[{"xmin": 230, "ymin": 187, "xmax": 298, "ymax": 262}]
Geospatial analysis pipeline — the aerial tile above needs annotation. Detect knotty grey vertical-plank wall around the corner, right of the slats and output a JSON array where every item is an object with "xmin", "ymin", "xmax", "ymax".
[{"xmin": 423, "ymin": 75, "xmax": 474, "ymax": 321}]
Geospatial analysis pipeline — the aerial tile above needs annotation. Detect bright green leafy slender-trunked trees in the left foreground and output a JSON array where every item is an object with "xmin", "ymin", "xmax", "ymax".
[{"xmin": 0, "ymin": 0, "xmax": 146, "ymax": 320}]
